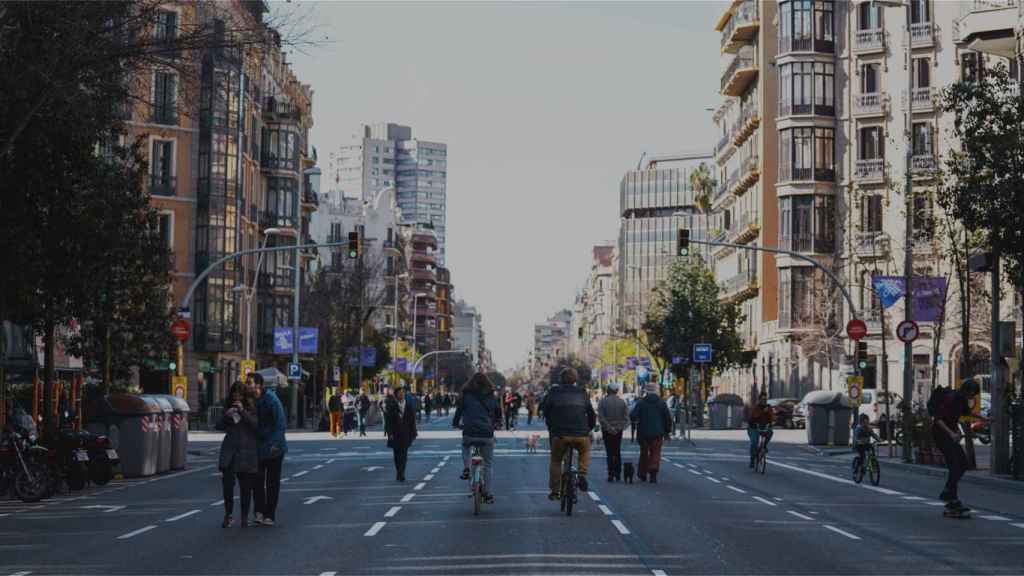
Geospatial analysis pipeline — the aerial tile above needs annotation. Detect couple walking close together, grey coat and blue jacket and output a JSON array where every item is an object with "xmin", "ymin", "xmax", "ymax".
[{"xmin": 217, "ymin": 374, "xmax": 288, "ymax": 528}]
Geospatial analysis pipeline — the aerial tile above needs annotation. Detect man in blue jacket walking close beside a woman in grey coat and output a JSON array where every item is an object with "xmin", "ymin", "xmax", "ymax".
[{"xmin": 253, "ymin": 373, "xmax": 288, "ymax": 526}]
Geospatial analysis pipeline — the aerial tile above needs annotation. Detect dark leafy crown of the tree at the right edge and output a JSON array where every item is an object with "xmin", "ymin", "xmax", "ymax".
[{"xmin": 938, "ymin": 64, "xmax": 1024, "ymax": 291}]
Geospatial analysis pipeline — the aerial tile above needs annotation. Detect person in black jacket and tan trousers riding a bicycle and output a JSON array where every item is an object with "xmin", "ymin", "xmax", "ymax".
[{"xmin": 542, "ymin": 368, "xmax": 597, "ymax": 500}]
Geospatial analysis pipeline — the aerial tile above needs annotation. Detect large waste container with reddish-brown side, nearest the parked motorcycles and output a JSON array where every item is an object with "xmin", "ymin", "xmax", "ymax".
[{"xmin": 106, "ymin": 394, "xmax": 163, "ymax": 478}]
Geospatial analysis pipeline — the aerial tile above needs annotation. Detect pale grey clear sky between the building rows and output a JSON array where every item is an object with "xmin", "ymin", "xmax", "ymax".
[{"xmin": 290, "ymin": 1, "xmax": 727, "ymax": 369}]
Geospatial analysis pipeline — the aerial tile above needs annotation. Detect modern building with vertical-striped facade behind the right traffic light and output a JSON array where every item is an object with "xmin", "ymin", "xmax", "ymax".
[{"xmin": 614, "ymin": 154, "xmax": 713, "ymax": 338}]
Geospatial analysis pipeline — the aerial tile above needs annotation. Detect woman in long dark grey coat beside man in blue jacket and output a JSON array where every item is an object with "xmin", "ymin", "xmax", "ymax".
[{"xmin": 216, "ymin": 381, "xmax": 262, "ymax": 528}]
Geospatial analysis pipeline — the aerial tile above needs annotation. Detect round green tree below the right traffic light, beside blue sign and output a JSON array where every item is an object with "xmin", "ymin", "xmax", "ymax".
[{"xmin": 644, "ymin": 258, "xmax": 743, "ymax": 375}]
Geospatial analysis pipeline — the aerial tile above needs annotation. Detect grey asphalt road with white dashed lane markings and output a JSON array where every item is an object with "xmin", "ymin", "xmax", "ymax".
[{"xmin": 0, "ymin": 412, "xmax": 1024, "ymax": 576}]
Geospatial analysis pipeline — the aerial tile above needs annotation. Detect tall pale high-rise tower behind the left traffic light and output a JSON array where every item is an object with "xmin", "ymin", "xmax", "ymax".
[{"xmin": 335, "ymin": 123, "xmax": 447, "ymax": 265}]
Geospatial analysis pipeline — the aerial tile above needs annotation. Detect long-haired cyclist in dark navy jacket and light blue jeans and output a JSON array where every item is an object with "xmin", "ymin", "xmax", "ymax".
[{"xmin": 452, "ymin": 372, "xmax": 501, "ymax": 504}]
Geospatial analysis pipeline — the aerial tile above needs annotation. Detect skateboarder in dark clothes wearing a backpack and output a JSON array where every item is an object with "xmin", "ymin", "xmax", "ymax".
[{"xmin": 928, "ymin": 378, "xmax": 978, "ymax": 513}]
